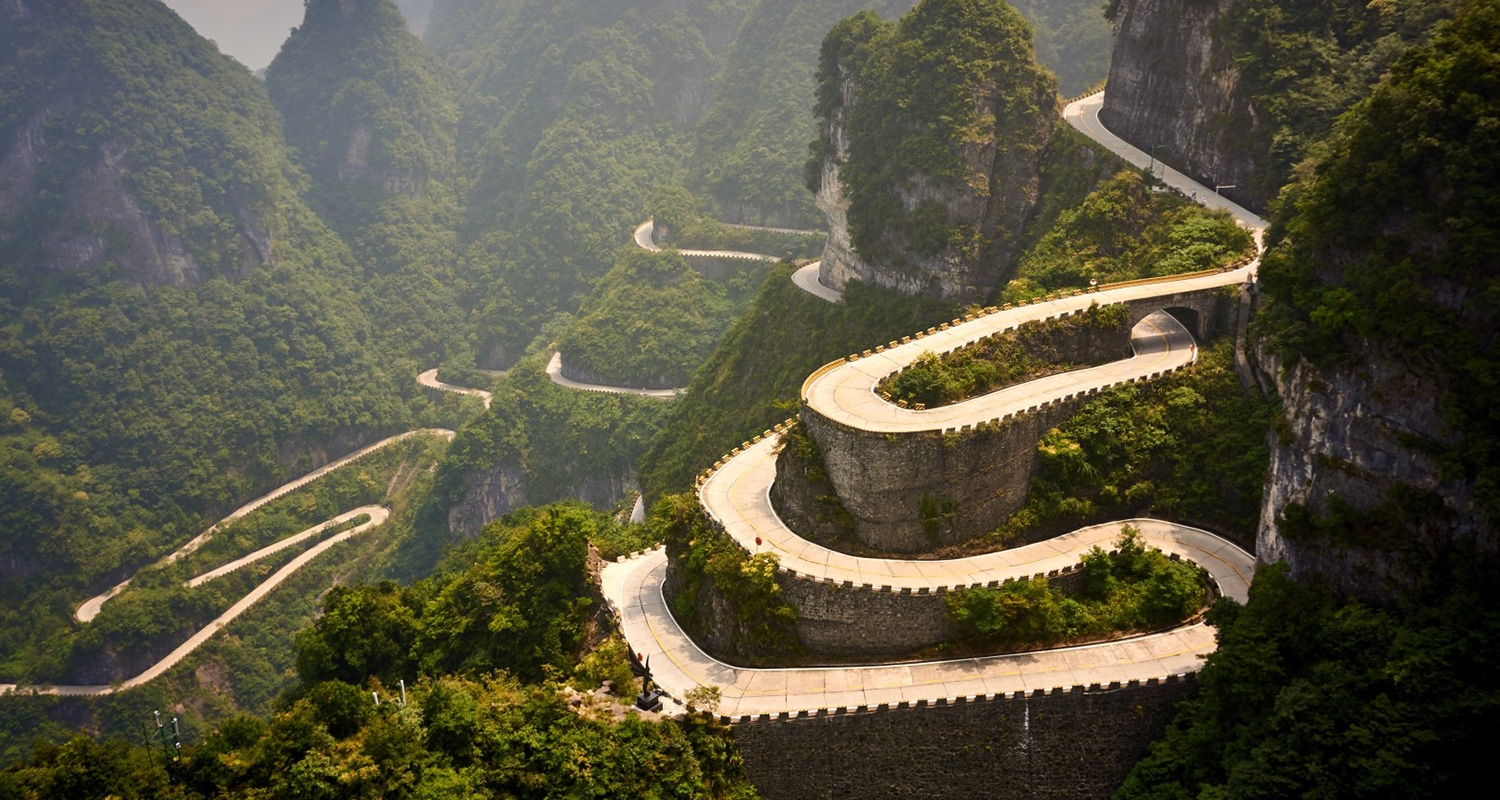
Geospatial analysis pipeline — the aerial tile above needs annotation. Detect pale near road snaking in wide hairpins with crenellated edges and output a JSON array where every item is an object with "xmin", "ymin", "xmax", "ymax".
[{"xmin": 603, "ymin": 93, "xmax": 1265, "ymax": 719}]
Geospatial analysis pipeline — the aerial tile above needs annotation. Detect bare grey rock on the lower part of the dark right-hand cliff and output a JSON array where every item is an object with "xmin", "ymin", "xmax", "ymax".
[{"xmin": 1256, "ymin": 347, "xmax": 1496, "ymax": 600}]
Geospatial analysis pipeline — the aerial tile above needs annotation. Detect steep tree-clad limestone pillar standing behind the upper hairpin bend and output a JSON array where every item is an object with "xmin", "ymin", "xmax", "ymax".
[{"xmin": 809, "ymin": 0, "xmax": 1056, "ymax": 302}]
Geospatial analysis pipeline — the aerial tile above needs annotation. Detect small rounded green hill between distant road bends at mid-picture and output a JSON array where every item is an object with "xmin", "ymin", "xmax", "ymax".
[{"xmin": 558, "ymin": 246, "xmax": 734, "ymax": 389}]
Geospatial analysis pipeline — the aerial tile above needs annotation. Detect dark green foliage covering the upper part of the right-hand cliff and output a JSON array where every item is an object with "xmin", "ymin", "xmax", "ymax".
[{"xmin": 1257, "ymin": 2, "xmax": 1500, "ymax": 519}]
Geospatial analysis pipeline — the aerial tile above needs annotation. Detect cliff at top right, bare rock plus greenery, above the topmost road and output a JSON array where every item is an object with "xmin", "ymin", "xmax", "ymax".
[{"xmin": 1100, "ymin": 0, "xmax": 1452, "ymax": 210}]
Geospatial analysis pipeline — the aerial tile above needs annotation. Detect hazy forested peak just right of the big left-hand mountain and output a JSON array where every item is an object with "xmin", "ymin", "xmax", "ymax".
[{"xmin": 266, "ymin": 0, "xmax": 474, "ymax": 365}]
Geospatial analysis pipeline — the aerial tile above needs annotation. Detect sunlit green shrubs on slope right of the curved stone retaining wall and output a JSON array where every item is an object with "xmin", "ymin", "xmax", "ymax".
[{"xmin": 999, "ymin": 341, "xmax": 1277, "ymax": 543}]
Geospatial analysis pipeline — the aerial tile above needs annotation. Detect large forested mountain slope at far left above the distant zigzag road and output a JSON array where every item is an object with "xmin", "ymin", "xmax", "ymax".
[{"xmin": 0, "ymin": 0, "xmax": 420, "ymax": 687}]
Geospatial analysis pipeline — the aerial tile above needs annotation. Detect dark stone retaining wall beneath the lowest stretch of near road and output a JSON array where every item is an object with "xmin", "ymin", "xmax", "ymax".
[{"xmin": 732, "ymin": 680, "xmax": 1197, "ymax": 800}]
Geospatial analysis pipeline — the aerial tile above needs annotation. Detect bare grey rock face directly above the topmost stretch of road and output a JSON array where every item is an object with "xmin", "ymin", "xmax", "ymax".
[{"xmin": 1100, "ymin": 0, "xmax": 1269, "ymax": 209}]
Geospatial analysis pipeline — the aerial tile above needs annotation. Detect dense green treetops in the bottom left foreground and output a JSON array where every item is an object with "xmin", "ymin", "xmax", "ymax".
[{"xmin": 0, "ymin": 504, "xmax": 755, "ymax": 800}]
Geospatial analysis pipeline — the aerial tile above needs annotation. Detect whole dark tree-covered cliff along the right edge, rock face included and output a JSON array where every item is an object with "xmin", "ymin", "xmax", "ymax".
[{"xmin": 1256, "ymin": 4, "xmax": 1500, "ymax": 599}]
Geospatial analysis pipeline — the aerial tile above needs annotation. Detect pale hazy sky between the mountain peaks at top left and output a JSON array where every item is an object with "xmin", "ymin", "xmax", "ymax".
[{"xmin": 162, "ymin": 0, "xmax": 432, "ymax": 69}]
